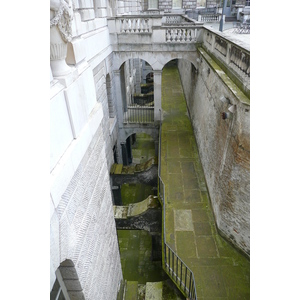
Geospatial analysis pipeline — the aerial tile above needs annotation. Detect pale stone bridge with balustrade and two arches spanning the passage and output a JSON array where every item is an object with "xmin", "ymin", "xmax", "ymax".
[{"xmin": 108, "ymin": 15, "xmax": 202, "ymax": 123}]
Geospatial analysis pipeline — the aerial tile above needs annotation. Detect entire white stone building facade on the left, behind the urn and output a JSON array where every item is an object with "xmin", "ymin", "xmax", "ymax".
[{"xmin": 50, "ymin": 0, "xmax": 122, "ymax": 300}]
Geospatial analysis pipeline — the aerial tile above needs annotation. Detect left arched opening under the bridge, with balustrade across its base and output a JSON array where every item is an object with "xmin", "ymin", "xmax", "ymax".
[{"xmin": 120, "ymin": 58, "xmax": 154, "ymax": 124}]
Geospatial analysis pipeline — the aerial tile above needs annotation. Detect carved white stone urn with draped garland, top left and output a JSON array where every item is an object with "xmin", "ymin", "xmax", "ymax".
[{"xmin": 50, "ymin": 0, "xmax": 73, "ymax": 77}]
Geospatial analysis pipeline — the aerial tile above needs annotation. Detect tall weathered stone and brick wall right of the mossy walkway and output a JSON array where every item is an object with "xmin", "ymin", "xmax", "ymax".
[{"xmin": 178, "ymin": 52, "xmax": 250, "ymax": 255}]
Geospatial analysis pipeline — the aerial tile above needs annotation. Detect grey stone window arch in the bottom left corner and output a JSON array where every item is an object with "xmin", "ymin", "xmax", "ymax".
[{"xmin": 50, "ymin": 259, "xmax": 85, "ymax": 300}]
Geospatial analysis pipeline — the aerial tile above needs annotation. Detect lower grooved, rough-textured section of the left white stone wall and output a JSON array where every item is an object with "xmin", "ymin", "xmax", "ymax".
[{"xmin": 51, "ymin": 126, "xmax": 122, "ymax": 300}]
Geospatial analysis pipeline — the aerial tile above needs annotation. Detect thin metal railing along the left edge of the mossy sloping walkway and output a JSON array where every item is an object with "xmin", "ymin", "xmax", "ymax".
[{"xmin": 158, "ymin": 110, "xmax": 197, "ymax": 300}]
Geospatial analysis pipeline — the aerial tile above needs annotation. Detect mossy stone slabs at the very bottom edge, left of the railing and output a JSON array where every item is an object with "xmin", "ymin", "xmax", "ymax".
[{"xmin": 117, "ymin": 280, "xmax": 185, "ymax": 300}]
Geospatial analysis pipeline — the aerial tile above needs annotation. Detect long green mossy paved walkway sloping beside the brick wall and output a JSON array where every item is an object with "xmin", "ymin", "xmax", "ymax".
[{"xmin": 161, "ymin": 66, "xmax": 250, "ymax": 300}]
